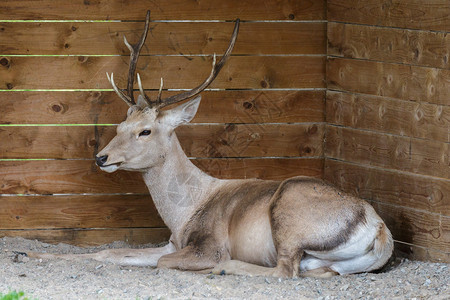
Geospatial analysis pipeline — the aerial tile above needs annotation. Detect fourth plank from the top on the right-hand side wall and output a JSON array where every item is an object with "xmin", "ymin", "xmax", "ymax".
[{"xmin": 326, "ymin": 91, "xmax": 450, "ymax": 143}]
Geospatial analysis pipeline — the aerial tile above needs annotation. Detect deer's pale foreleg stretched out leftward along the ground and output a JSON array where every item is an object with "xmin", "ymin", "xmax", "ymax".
[{"xmin": 26, "ymin": 242, "xmax": 176, "ymax": 267}]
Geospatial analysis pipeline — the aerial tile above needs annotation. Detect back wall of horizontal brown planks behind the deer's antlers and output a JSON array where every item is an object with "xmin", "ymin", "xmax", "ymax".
[{"xmin": 0, "ymin": 0, "xmax": 326, "ymax": 245}]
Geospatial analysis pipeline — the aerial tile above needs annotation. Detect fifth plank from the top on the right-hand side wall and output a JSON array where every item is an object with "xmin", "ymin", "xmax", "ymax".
[{"xmin": 325, "ymin": 126, "xmax": 450, "ymax": 179}]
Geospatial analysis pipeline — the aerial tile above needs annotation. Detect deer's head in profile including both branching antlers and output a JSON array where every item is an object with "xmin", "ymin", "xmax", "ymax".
[{"xmin": 96, "ymin": 11, "xmax": 239, "ymax": 172}]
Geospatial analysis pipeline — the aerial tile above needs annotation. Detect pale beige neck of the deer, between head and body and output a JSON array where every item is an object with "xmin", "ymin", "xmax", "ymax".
[{"xmin": 143, "ymin": 133, "xmax": 220, "ymax": 237}]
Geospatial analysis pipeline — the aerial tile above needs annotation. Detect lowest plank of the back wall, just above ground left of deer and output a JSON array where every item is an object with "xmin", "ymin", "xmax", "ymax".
[{"xmin": 0, "ymin": 228, "xmax": 170, "ymax": 246}]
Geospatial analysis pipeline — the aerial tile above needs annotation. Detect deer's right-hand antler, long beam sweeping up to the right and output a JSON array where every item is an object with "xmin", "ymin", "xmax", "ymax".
[{"xmin": 158, "ymin": 19, "xmax": 240, "ymax": 108}]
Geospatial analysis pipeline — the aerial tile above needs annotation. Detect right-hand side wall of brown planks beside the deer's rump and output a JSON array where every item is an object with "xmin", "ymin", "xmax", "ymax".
[{"xmin": 324, "ymin": 0, "xmax": 450, "ymax": 262}]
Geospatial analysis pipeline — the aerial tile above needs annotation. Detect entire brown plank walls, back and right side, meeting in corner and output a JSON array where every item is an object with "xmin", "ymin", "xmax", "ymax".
[{"xmin": 0, "ymin": 0, "xmax": 450, "ymax": 261}]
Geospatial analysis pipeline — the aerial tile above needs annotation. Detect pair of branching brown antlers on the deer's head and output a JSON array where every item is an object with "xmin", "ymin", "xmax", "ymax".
[{"xmin": 107, "ymin": 11, "xmax": 240, "ymax": 109}]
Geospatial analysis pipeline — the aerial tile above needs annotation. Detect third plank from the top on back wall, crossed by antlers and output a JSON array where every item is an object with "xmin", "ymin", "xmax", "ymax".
[{"xmin": 0, "ymin": 56, "xmax": 325, "ymax": 90}]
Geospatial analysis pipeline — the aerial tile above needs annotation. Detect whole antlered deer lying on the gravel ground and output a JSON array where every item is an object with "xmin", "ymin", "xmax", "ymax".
[{"xmin": 24, "ymin": 11, "xmax": 393, "ymax": 277}]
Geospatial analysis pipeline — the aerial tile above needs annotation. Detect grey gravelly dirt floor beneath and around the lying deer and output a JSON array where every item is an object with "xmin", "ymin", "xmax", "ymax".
[{"xmin": 0, "ymin": 238, "xmax": 450, "ymax": 300}]
